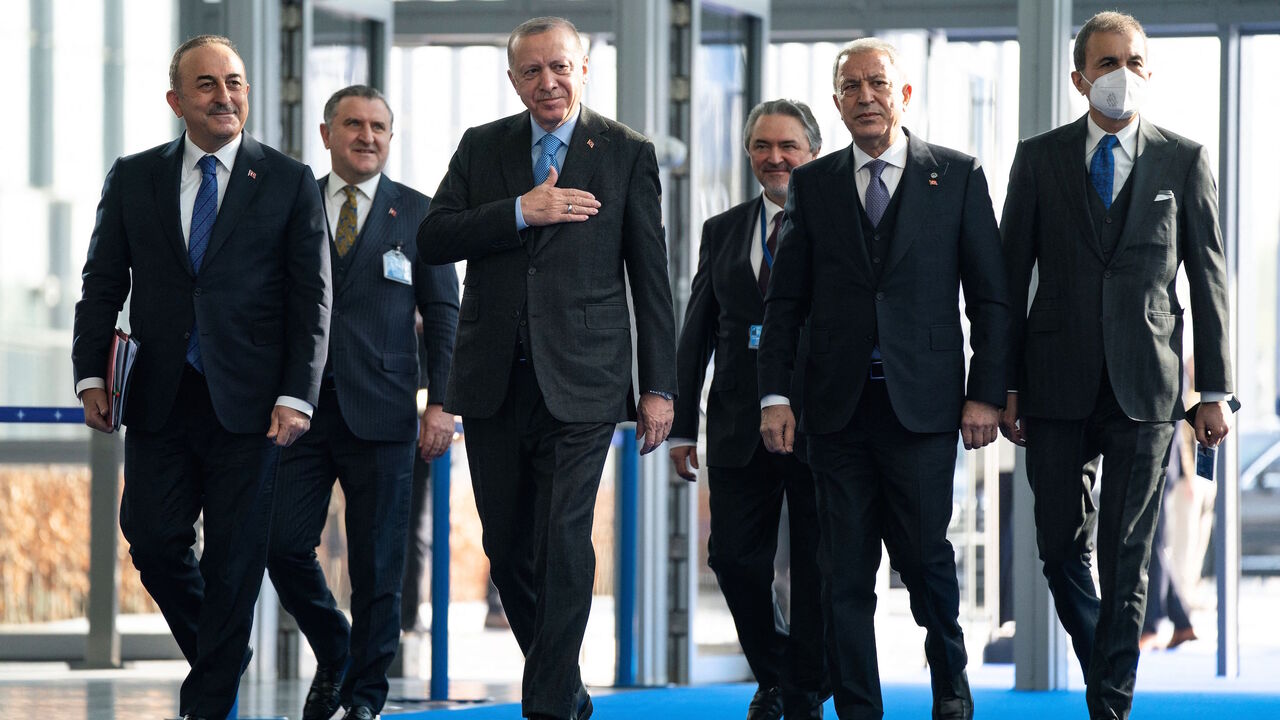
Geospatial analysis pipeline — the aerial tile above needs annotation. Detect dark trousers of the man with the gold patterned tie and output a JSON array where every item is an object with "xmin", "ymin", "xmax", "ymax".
[{"xmin": 268, "ymin": 389, "xmax": 415, "ymax": 714}]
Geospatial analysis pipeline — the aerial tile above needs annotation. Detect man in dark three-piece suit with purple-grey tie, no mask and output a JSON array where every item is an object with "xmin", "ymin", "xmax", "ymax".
[{"xmin": 759, "ymin": 38, "xmax": 1009, "ymax": 719}]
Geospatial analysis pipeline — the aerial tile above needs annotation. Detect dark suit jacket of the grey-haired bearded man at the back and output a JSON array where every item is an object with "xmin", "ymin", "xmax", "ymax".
[{"xmin": 671, "ymin": 196, "xmax": 805, "ymax": 468}]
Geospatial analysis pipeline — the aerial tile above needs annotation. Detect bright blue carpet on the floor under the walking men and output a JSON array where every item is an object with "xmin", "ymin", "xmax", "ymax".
[{"xmin": 388, "ymin": 684, "xmax": 1280, "ymax": 720}]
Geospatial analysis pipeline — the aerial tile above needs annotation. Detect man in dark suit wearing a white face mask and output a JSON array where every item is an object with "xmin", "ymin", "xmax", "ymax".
[{"xmin": 1001, "ymin": 13, "xmax": 1231, "ymax": 717}]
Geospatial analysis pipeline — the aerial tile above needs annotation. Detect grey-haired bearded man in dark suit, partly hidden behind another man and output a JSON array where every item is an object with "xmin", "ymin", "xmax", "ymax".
[{"xmin": 668, "ymin": 100, "xmax": 827, "ymax": 720}]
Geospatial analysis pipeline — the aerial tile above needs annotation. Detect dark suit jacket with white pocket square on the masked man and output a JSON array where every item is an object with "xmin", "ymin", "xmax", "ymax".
[{"xmin": 1001, "ymin": 117, "xmax": 1233, "ymax": 421}]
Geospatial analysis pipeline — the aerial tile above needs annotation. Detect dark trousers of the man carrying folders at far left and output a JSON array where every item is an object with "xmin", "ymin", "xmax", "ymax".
[{"xmin": 120, "ymin": 366, "xmax": 279, "ymax": 719}]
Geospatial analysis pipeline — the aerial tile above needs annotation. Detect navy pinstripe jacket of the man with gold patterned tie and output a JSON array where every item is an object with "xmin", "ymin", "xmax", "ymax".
[{"xmin": 320, "ymin": 176, "xmax": 458, "ymax": 442}]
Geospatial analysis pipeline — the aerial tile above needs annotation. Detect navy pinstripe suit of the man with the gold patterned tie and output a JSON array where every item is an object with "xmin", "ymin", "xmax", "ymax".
[{"xmin": 268, "ymin": 170, "xmax": 458, "ymax": 712}]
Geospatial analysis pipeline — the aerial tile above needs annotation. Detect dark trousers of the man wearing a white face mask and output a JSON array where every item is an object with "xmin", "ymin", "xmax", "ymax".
[{"xmin": 1025, "ymin": 374, "xmax": 1174, "ymax": 719}]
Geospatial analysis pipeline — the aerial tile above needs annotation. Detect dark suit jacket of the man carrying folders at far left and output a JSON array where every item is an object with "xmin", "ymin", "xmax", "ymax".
[{"xmin": 72, "ymin": 132, "xmax": 332, "ymax": 433}]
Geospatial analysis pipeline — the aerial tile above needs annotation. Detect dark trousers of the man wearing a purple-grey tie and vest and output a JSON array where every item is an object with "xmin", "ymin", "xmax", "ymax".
[{"xmin": 809, "ymin": 380, "xmax": 968, "ymax": 720}]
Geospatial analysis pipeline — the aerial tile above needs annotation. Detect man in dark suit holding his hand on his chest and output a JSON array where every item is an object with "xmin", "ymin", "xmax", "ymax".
[{"xmin": 417, "ymin": 18, "xmax": 676, "ymax": 719}]
